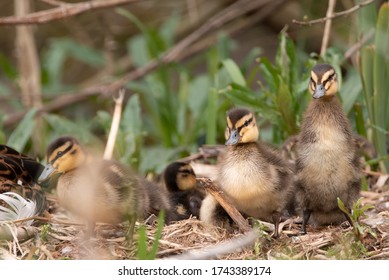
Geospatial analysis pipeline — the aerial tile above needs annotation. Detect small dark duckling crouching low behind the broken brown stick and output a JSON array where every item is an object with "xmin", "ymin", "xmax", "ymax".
[{"xmin": 163, "ymin": 162, "xmax": 205, "ymax": 220}]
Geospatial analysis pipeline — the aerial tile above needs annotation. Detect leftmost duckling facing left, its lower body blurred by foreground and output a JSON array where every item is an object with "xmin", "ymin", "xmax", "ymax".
[{"xmin": 39, "ymin": 137, "xmax": 174, "ymax": 233}]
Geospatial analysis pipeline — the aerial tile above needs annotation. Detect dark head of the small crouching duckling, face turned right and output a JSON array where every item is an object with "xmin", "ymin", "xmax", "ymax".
[{"xmin": 164, "ymin": 161, "xmax": 197, "ymax": 192}]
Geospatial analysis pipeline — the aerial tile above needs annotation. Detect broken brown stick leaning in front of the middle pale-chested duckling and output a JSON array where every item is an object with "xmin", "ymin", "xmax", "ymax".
[{"xmin": 198, "ymin": 178, "xmax": 251, "ymax": 232}]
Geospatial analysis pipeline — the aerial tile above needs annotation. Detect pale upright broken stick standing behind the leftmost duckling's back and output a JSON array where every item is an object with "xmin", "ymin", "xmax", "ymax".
[{"xmin": 103, "ymin": 88, "xmax": 125, "ymax": 160}]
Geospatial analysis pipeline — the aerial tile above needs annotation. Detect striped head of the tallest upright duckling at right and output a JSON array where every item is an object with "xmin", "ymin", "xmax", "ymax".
[{"xmin": 309, "ymin": 64, "xmax": 338, "ymax": 99}]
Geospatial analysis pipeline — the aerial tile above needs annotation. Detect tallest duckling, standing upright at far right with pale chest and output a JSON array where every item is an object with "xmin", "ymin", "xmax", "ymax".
[{"xmin": 296, "ymin": 64, "xmax": 361, "ymax": 233}]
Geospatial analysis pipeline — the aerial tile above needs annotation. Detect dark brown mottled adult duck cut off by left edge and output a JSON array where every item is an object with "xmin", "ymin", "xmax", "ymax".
[{"xmin": 0, "ymin": 145, "xmax": 47, "ymax": 219}]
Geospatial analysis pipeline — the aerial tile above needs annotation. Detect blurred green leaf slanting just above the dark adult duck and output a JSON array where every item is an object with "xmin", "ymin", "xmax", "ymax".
[{"xmin": 7, "ymin": 109, "xmax": 37, "ymax": 151}]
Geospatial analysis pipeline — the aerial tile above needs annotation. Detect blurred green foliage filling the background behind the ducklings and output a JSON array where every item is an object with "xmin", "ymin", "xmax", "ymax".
[{"xmin": 0, "ymin": 2, "xmax": 389, "ymax": 177}]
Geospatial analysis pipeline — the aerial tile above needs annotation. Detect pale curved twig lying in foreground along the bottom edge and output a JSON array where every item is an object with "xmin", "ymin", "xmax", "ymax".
[{"xmin": 165, "ymin": 230, "xmax": 258, "ymax": 260}]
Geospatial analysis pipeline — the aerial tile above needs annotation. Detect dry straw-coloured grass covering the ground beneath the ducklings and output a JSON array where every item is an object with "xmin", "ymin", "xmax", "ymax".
[{"xmin": 0, "ymin": 173, "xmax": 389, "ymax": 259}]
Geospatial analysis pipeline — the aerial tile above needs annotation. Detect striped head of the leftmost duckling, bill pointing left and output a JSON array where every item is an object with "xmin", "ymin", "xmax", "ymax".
[{"xmin": 38, "ymin": 136, "xmax": 86, "ymax": 182}]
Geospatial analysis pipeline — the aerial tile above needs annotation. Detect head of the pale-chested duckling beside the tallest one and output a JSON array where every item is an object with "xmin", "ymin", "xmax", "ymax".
[{"xmin": 224, "ymin": 108, "xmax": 259, "ymax": 145}]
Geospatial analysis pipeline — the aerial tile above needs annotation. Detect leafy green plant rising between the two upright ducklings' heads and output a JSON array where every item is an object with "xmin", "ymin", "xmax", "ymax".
[{"xmin": 223, "ymin": 30, "xmax": 315, "ymax": 144}]
